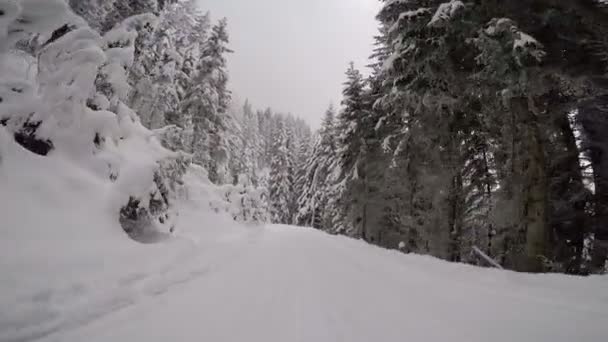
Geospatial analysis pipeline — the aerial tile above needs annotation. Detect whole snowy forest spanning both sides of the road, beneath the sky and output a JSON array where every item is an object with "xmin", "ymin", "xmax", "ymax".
[{"xmin": 0, "ymin": 0, "xmax": 608, "ymax": 274}]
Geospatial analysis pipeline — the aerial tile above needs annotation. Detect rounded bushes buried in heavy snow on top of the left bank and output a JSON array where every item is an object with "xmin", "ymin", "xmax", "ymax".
[{"xmin": 0, "ymin": 0, "xmax": 189, "ymax": 241}]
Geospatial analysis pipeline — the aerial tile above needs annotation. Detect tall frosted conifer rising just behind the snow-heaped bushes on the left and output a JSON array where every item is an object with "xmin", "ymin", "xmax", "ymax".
[{"xmin": 130, "ymin": 1, "xmax": 209, "ymax": 132}]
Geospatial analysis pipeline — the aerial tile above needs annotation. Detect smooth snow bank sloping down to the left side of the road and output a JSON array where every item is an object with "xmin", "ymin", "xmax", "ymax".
[{"xmin": 0, "ymin": 126, "xmax": 252, "ymax": 341}]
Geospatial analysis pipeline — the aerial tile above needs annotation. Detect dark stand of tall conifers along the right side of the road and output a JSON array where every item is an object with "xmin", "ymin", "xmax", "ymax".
[{"xmin": 318, "ymin": 0, "xmax": 608, "ymax": 274}]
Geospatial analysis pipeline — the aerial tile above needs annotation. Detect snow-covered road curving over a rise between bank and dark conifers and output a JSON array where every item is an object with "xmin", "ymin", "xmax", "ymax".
[{"xmin": 10, "ymin": 226, "xmax": 608, "ymax": 342}]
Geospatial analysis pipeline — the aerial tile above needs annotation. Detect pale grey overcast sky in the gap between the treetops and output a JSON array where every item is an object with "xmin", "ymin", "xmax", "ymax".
[{"xmin": 200, "ymin": 0, "xmax": 379, "ymax": 127}]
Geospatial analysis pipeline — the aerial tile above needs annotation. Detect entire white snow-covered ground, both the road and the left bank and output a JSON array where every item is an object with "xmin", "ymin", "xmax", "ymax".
[{"xmin": 0, "ymin": 128, "xmax": 608, "ymax": 342}]
